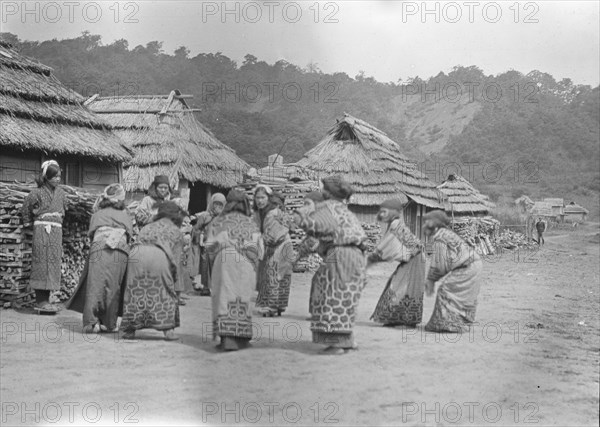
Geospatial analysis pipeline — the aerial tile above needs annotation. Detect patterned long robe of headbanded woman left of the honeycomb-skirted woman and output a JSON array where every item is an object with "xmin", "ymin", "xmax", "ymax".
[{"xmin": 254, "ymin": 208, "xmax": 296, "ymax": 313}]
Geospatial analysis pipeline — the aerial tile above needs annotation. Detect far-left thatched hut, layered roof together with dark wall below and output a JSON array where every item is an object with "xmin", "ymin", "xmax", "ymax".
[{"xmin": 0, "ymin": 41, "xmax": 131, "ymax": 190}]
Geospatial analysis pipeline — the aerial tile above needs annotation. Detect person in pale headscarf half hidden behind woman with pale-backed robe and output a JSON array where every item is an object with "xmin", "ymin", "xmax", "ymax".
[{"xmin": 192, "ymin": 193, "xmax": 225, "ymax": 296}]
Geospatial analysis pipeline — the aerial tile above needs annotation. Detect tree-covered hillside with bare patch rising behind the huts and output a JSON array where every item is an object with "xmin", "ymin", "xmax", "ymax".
[{"xmin": 2, "ymin": 32, "xmax": 600, "ymax": 215}]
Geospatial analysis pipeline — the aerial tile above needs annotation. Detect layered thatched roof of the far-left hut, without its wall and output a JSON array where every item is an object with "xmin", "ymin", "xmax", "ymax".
[{"xmin": 0, "ymin": 41, "xmax": 131, "ymax": 162}]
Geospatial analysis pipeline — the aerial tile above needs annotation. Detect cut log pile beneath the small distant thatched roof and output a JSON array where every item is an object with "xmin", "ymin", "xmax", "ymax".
[{"xmin": 452, "ymin": 217, "xmax": 500, "ymax": 255}]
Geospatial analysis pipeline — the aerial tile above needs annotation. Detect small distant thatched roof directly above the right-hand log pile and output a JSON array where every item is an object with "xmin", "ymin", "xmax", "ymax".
[{"xmin": 438, "ymin": 174, "xmax": 496, "ymax": 214}]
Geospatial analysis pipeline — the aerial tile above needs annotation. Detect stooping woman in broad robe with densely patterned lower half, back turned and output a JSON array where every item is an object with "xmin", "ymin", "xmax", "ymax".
[{"xmin": 121, "ymin": 201, "xmax": 185, "ymax": 340}]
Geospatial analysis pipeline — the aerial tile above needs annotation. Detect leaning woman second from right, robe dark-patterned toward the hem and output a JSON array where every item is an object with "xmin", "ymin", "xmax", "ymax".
[{"xmin": 367, "ymin": 199, "xmax": 425, "ymax": 326}]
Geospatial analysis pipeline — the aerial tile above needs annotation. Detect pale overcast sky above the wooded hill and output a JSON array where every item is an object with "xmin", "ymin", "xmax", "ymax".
[{"xmin": 0, "ymin": 0, "xmax": 600, "ymax": 86}]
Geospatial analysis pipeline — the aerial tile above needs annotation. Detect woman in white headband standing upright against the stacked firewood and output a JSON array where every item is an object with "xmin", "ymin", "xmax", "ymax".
[{"xmin": 21, "ymin": 160, "xmax": 68, "ymax": 313}]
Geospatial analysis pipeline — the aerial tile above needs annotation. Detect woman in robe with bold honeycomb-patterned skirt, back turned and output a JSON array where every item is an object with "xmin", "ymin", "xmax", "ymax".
[{"xmin": 296, "ymin": 175, "xmax": 367, "ymax": 354}]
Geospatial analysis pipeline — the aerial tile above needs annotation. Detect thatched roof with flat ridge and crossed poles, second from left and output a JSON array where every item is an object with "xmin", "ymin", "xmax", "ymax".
[{"xmin": 86, "ymin": 90, "xmax": 249, "ymax": 191}]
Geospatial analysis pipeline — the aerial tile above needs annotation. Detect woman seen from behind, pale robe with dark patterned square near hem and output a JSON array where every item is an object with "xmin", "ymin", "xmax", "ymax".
[{"xmin": 206, "ymin": 189, "xmax": 263, "ymax": 350}]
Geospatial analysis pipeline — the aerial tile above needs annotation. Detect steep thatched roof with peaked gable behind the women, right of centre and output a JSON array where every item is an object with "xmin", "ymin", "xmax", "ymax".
[{"xmin": 298, "ymin": 114, "xmax": 444, "ymax": 208}]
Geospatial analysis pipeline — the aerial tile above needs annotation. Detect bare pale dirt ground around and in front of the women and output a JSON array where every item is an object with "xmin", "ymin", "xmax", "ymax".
[{"xmin": 0, "ymin": 223, "xmax": 600, "ymax": 426}]
